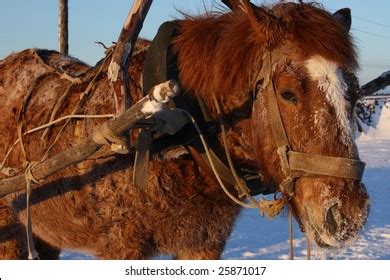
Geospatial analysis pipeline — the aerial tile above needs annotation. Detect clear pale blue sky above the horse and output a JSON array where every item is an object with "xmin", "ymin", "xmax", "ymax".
[{"xmin": 0, "ymin": 0, "xmax": 390, "ymax": 83}]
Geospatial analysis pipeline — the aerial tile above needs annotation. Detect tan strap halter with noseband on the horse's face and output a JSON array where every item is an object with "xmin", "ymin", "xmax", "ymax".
[{"xmin": 256, "ymin": 44, "xmax": 366, "ymax": 228}]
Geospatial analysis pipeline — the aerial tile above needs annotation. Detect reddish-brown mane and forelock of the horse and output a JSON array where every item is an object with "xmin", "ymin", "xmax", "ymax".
[{"xmin": 173, "ymin": 3, "xmax": 357, "ymax": 107}]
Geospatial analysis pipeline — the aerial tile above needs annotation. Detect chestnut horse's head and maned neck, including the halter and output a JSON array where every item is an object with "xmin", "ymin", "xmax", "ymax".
[{"xmin": 174, "ymin": 1, "xmax": 369, "ymax": 247}]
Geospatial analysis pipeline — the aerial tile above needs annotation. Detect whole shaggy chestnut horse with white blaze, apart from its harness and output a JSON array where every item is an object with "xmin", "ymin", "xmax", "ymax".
[{"xmin": 0, "ymin": 3, "xmax": 369, "ymax": 259}]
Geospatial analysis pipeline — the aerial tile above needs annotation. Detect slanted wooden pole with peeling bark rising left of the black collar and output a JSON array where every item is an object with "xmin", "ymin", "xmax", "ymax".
[{"xmin": 107, "ymin": 0, "xmax": 153, "ymax": 115}]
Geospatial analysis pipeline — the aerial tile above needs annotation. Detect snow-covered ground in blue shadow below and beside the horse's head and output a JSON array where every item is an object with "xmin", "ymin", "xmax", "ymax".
[{"xmin": 61, "ymin": 98, "xmax": 390, "ymax": 260}]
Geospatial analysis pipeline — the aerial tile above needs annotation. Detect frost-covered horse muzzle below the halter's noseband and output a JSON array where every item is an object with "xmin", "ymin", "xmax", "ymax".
[{"xmin": 297, "ymin": 179, "xmax": 369, "ymax": 248}]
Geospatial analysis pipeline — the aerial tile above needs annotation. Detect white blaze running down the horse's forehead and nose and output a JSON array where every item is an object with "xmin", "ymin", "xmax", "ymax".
[{"xmin": 305, "ymin": 55, "xmax": 352, "ymax": 142}]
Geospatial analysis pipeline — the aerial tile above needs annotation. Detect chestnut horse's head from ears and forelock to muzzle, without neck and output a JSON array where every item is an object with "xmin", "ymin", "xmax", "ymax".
[{"xmin": 244, "ymin": 3, "xmax": 369, "ymax": 247}]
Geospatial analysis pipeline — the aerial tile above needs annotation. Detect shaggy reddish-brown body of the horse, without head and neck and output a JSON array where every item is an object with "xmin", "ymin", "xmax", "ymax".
[{"xmin": 0, "ymin": 47, "xmax": 239, "ymax": 259}]
